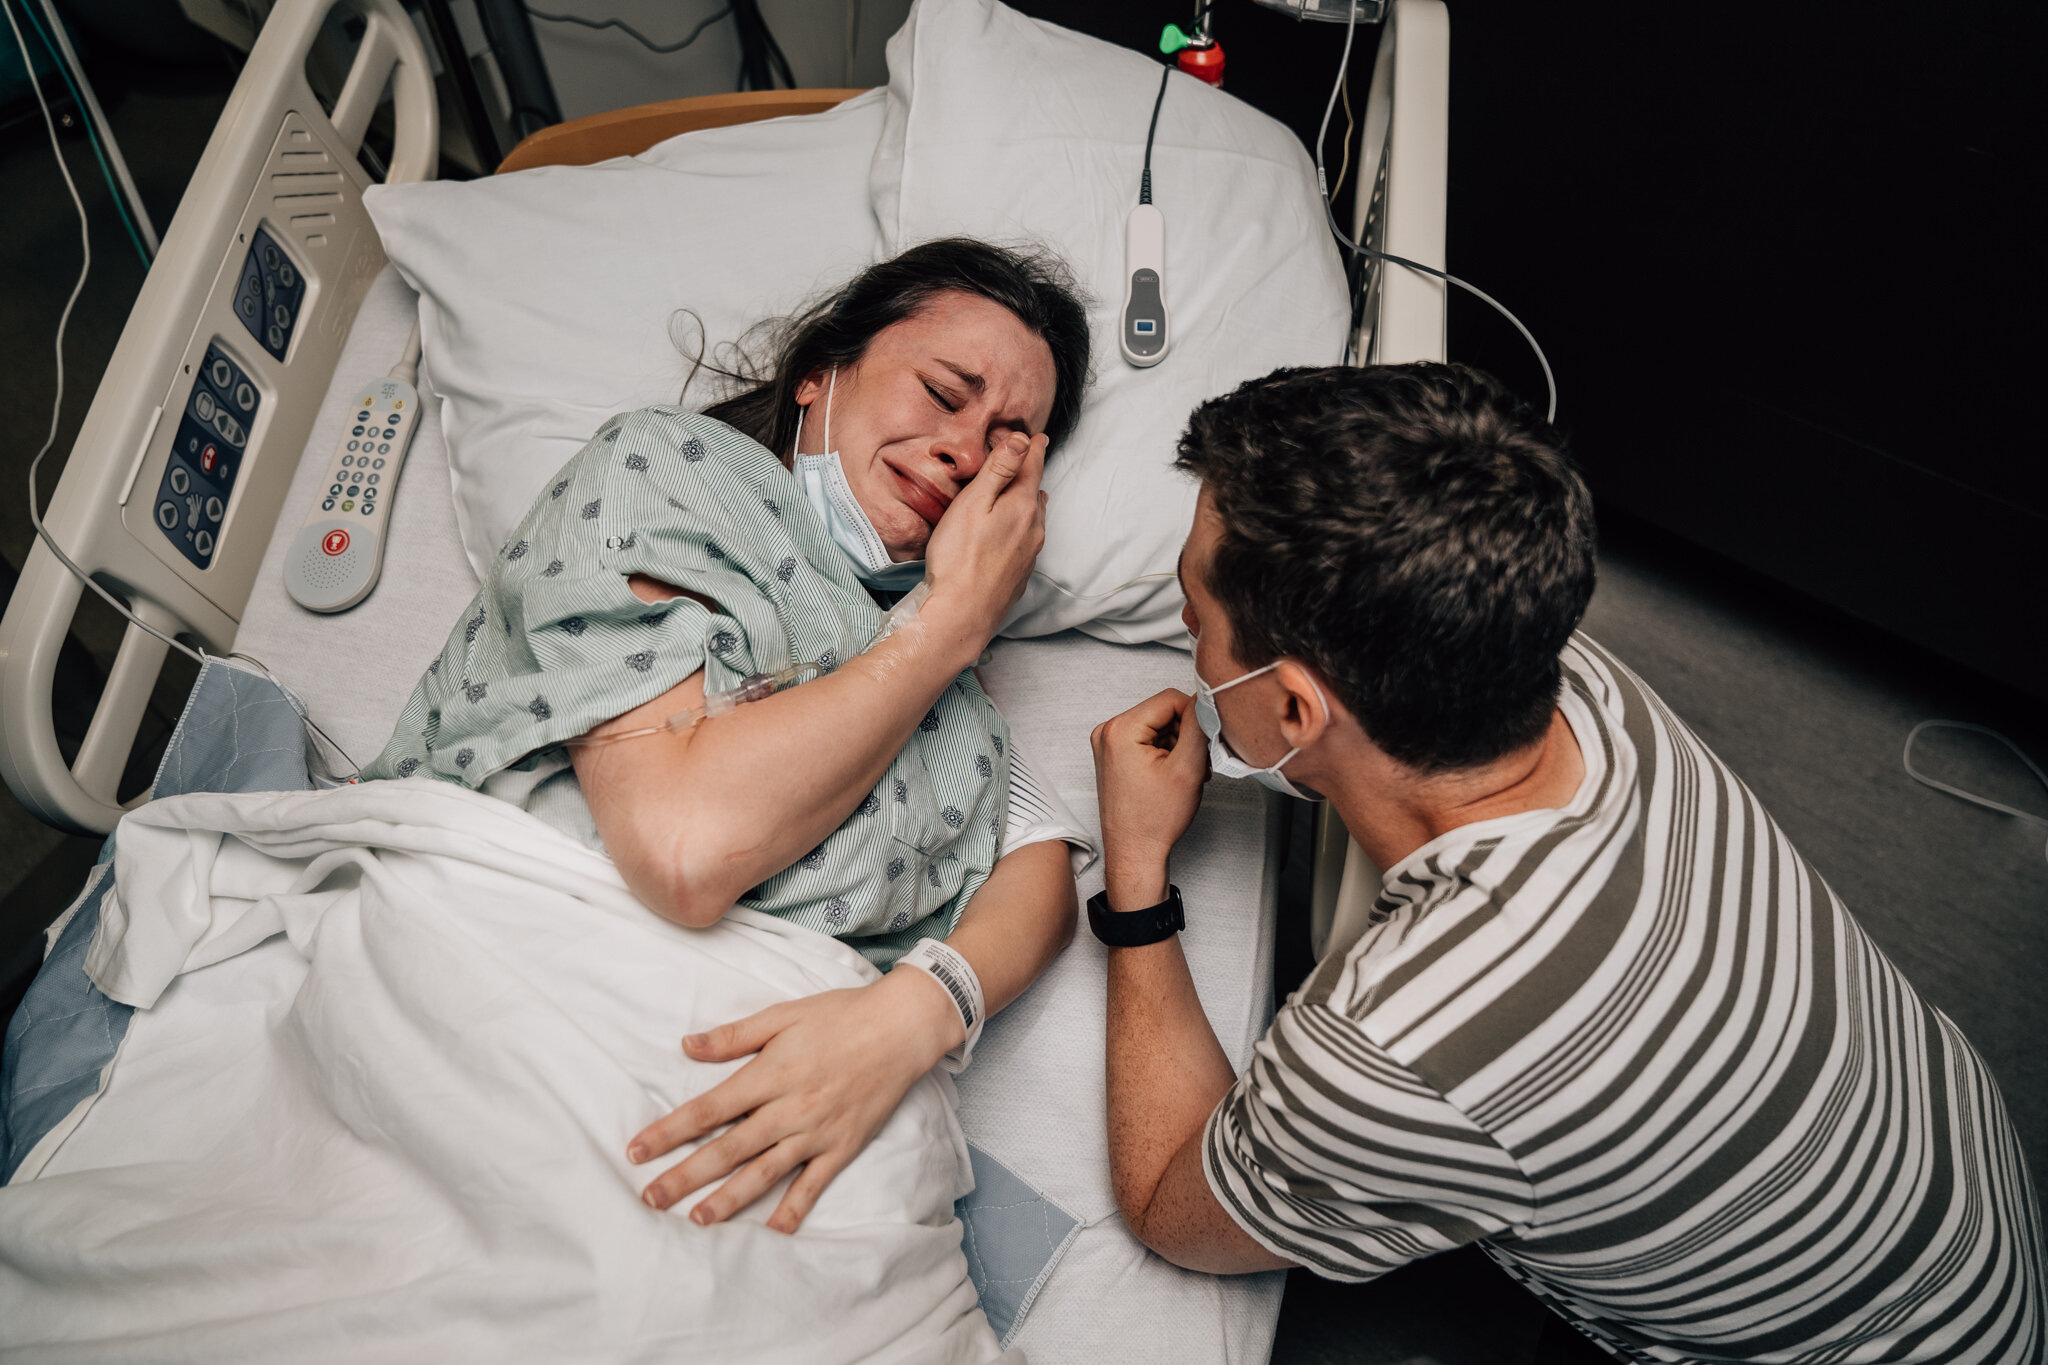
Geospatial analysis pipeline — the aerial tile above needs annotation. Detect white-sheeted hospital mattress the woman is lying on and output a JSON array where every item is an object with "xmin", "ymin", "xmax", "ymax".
[{"xmin": 224, "ymin": 268, "xmax": 1284, "ymax": 1365}]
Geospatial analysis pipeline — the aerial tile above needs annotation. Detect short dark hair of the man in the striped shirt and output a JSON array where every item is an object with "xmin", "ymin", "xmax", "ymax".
[{"xmin": 1178, "ymin": 364, "xmax": 1593, "ymax": 774}]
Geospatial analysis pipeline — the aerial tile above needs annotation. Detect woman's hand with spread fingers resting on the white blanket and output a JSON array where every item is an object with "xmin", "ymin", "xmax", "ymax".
[{"xmin": 627, "ymin": 968, "xmax": 965, "ymax": 1232}]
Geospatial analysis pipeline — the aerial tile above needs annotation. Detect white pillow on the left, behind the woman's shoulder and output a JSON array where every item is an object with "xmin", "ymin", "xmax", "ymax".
[{"xmin": 365, "ymin": 90, "xmax": 883, "ymax": 577}]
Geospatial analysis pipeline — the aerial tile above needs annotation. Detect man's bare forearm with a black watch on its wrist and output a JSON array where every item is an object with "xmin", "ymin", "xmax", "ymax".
[{"xmin": 1106, "ymin": 862, "xmax": 1235, "ymax": 1232}]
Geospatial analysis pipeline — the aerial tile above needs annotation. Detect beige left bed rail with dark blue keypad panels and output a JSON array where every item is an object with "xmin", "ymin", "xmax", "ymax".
[{"xmin": 0, "ymin": 0, "xmax": 438, "ymax": 833}]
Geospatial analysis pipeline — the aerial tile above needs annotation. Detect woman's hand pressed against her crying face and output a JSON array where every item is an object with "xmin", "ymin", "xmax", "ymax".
[{"xmin": 924, "ymin": 432, "xmax": 1047, "ymax": 655}]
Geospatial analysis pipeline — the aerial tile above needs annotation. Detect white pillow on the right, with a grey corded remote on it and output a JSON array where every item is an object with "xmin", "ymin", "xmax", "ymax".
[{"xmin": 870, "ymin": 0, "xmax": 1350, "ymax": 645}]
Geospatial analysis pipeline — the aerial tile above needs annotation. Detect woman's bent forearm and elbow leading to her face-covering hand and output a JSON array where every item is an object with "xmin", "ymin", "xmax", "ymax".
[{"xmin": 571, "ymin": 604, "xmax": 985, "ymax": 925}]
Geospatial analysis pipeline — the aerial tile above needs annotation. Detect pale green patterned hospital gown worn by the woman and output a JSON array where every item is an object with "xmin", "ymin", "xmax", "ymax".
[{"xmin": 362, "ymin": 407, "xmax": 1010, "ymax": 968}]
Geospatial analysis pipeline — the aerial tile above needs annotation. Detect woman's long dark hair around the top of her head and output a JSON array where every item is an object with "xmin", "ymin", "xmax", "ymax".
[{"xmin": 692, "ymin": 237, "xmax": 1087, "ymax": 458}]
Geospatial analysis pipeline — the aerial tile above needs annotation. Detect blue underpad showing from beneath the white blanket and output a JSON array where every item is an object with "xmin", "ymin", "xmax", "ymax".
[{"xmin": 0, "ymin": 663, "xmax": 1079, "ymax": 1347}]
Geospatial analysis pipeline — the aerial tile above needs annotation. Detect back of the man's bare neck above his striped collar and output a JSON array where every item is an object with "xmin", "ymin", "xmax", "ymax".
[{"xmin": 1317, "ymin": 710, "xmax": 1585, "ymax": 870}]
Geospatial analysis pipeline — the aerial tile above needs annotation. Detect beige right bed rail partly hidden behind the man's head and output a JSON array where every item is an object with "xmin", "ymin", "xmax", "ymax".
[{"xmin": 1309, "ymin": 0, "xmax": 1450, "ymax": 958}]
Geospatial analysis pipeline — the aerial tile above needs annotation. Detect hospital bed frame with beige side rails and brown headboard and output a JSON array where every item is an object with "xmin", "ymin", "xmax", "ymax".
[{"xmin": 0, "ymin": 0, "xmax": 1450, "ymax": 952}]
